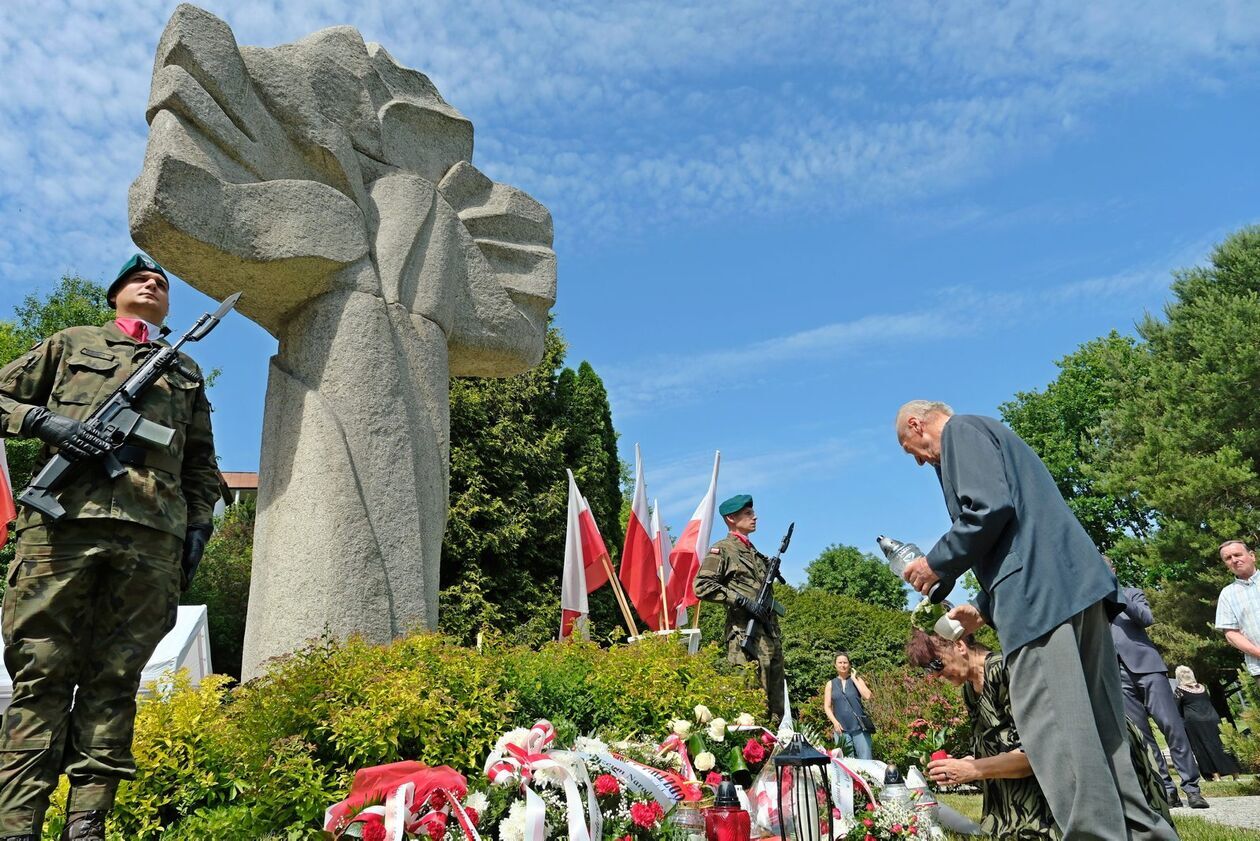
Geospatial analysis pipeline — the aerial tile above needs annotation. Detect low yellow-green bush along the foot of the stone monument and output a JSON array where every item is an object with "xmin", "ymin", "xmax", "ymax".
[{"xmin": 88, "ymin": 634, "xmax": 762, "ymax": 841}]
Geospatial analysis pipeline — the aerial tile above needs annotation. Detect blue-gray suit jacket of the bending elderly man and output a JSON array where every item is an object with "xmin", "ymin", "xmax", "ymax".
[{"xmin": 927, "ymin": 415, "xmax": 1124, "ymax": 654}]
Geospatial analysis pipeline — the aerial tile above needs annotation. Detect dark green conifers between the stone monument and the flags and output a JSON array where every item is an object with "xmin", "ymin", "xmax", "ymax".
[{"xmin": 440, "ymin": 328, "xmax": 622, "ymax": 643}]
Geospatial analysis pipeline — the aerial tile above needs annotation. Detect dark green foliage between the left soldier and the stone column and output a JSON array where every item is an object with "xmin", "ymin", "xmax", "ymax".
[{"xmin": 180, "ymin": 497, "xmax": 256, "ymax": 680}]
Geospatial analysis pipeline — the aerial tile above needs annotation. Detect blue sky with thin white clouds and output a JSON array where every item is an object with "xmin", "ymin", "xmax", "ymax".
[{"xmin": 0, "ymin": 0, "xmax": 1260, "ymax": 592}]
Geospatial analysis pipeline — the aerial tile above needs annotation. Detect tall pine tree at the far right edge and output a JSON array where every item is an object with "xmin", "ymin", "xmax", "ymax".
[{"xmin": 1099, "ymin": 227, "xmax": 1260, "ymax": 580}]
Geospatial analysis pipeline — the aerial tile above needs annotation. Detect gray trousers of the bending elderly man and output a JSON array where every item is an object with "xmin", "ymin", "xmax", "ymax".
[{"xmin": 1007, "ymin": 601, "xmax": 1177, "ymax": 841}]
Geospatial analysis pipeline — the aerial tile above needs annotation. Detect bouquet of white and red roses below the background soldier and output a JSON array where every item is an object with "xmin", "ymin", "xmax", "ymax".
[{"xmin": 660, "ymin": 705, "xmax": 775, "ymax": 788}]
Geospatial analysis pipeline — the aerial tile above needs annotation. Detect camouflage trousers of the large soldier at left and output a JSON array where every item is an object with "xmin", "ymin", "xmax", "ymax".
[{"xmin": 0, "ymin": 519, "xmax": 181, "ymax": 837}]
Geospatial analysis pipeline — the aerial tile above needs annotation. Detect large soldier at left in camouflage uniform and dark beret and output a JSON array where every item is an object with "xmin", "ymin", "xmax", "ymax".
[{"xmin": 0, "ymin": 255, "xmax": 219, "ymax": 841}]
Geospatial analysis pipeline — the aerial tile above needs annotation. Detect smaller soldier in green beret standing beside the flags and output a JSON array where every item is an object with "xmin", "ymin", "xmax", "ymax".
[{"xmin": 696, "ymin": 493, "xmax": 784, "ymax": 721}]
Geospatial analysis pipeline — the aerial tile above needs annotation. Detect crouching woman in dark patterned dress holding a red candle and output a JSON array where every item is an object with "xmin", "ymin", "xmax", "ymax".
[{"xmin": 906, "ymin": 628, "xmax": 1171, "ymax": 841}]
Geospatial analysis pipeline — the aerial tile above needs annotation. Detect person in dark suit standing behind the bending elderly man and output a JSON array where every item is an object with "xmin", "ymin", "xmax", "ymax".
[{"xmin": 1111, "ymin": 588, "xmax": 1208, "ymax": 809}]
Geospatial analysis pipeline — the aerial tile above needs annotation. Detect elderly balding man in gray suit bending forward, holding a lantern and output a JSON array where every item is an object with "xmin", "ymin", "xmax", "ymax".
[{"xmin": 897, "ymin": 400, "xmax": 1177, "ymax": 841}]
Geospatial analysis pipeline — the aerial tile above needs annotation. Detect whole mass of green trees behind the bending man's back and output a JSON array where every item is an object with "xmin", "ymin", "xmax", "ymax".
[{"xmin": 1002, "ymin": 227, "xmax": 1260, "ymax": 696}]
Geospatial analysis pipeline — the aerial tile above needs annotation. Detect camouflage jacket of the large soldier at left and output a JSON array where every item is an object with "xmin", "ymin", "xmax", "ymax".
[{"xmin": 0, "ymin": 322, "xmax": 219, "ymax": 537}]
